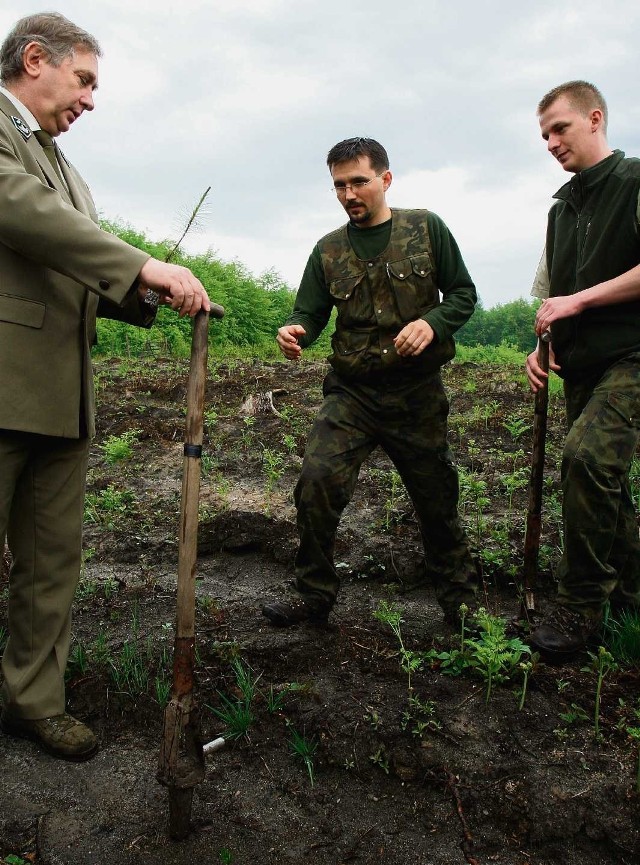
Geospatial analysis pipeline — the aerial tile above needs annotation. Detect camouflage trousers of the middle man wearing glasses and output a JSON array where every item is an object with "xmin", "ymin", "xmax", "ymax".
[{"xmin": 295, "ymin": 372, "xmax": 477, "ymax": 609}]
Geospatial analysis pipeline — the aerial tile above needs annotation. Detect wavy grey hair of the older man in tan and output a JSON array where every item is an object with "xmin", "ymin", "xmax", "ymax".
[{"xmin": 0, "ymin": 12, "xmax": 102, "ymax": 83}]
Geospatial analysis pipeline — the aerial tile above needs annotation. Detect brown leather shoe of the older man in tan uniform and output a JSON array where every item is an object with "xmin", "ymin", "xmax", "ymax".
[{"xmin": 0, "ymin": 709, "xmax": 98, "ymax": 760}]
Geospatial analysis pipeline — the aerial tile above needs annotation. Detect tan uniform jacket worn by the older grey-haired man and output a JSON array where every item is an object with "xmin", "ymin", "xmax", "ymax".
[{"xmin": 0, "ymin": 93, "xmax": 152, "ymax": 438}]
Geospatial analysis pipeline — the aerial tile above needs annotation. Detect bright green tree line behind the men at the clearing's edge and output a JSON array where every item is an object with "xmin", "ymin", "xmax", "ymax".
[{"xmin": 95, "ymin": 221, "xmax": 537, "ymax": 356}]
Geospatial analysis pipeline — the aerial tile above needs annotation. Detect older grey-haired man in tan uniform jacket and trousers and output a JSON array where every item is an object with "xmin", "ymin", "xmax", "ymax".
[{"xmin": 0, "ymin": 13, "xmax": 210, "ymax": 759}]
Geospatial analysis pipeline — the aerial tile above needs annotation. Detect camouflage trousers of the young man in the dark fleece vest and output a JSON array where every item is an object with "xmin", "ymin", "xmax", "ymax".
[{"xmin": 557, "ymin": 354, "xmax": 640, "ymax": 615}]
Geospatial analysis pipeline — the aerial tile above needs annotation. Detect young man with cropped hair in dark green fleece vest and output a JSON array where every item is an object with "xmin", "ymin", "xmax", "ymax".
[{"xmin": 527, "ymin": 81, "xmax": 640, "ymax": 663}]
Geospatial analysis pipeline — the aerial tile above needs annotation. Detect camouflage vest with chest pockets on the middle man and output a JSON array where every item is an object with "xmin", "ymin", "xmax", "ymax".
[{"xmin": 318, "ymin": 209, "xmax": 455, "ymax": 378}]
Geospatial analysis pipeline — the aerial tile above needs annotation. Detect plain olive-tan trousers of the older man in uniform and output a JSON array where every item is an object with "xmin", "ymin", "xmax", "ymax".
[{"xmin": 0, "ymin": 430, "xmax": 89, "ymax": 719}]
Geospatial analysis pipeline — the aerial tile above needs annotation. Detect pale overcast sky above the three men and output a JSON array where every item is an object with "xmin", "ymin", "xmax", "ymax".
[{"xmin": 0, "ymin": 0, "xmax": 640, "ymax": 308}]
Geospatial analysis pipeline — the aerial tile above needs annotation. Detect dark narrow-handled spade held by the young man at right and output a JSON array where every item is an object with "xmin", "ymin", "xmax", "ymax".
[{"xmin": 520, "ymin": 331, "xmax": 551, "ymax": 621}]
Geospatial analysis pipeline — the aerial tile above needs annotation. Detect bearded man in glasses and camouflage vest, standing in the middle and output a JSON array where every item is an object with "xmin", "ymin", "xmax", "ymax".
[{"xmin": 262, "ymin": 138, "xmax": 477, "ymax": 627}]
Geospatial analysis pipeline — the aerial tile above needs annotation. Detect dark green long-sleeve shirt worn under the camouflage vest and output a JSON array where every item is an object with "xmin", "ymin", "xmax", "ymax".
[{"xmin": 285, "ymin": 211, "xmax": 477, "ymax": 348}]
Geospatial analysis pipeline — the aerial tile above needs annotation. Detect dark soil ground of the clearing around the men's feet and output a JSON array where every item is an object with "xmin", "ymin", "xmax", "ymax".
[{"xmin": 0, "ymin": 352, "xmax": 640, "ymax": 865}]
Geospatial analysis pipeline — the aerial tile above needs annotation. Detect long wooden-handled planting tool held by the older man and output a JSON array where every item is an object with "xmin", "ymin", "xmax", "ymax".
[{"xmin": 157, "ymin": 304, "xmax": 224, "ymax": 840}]
